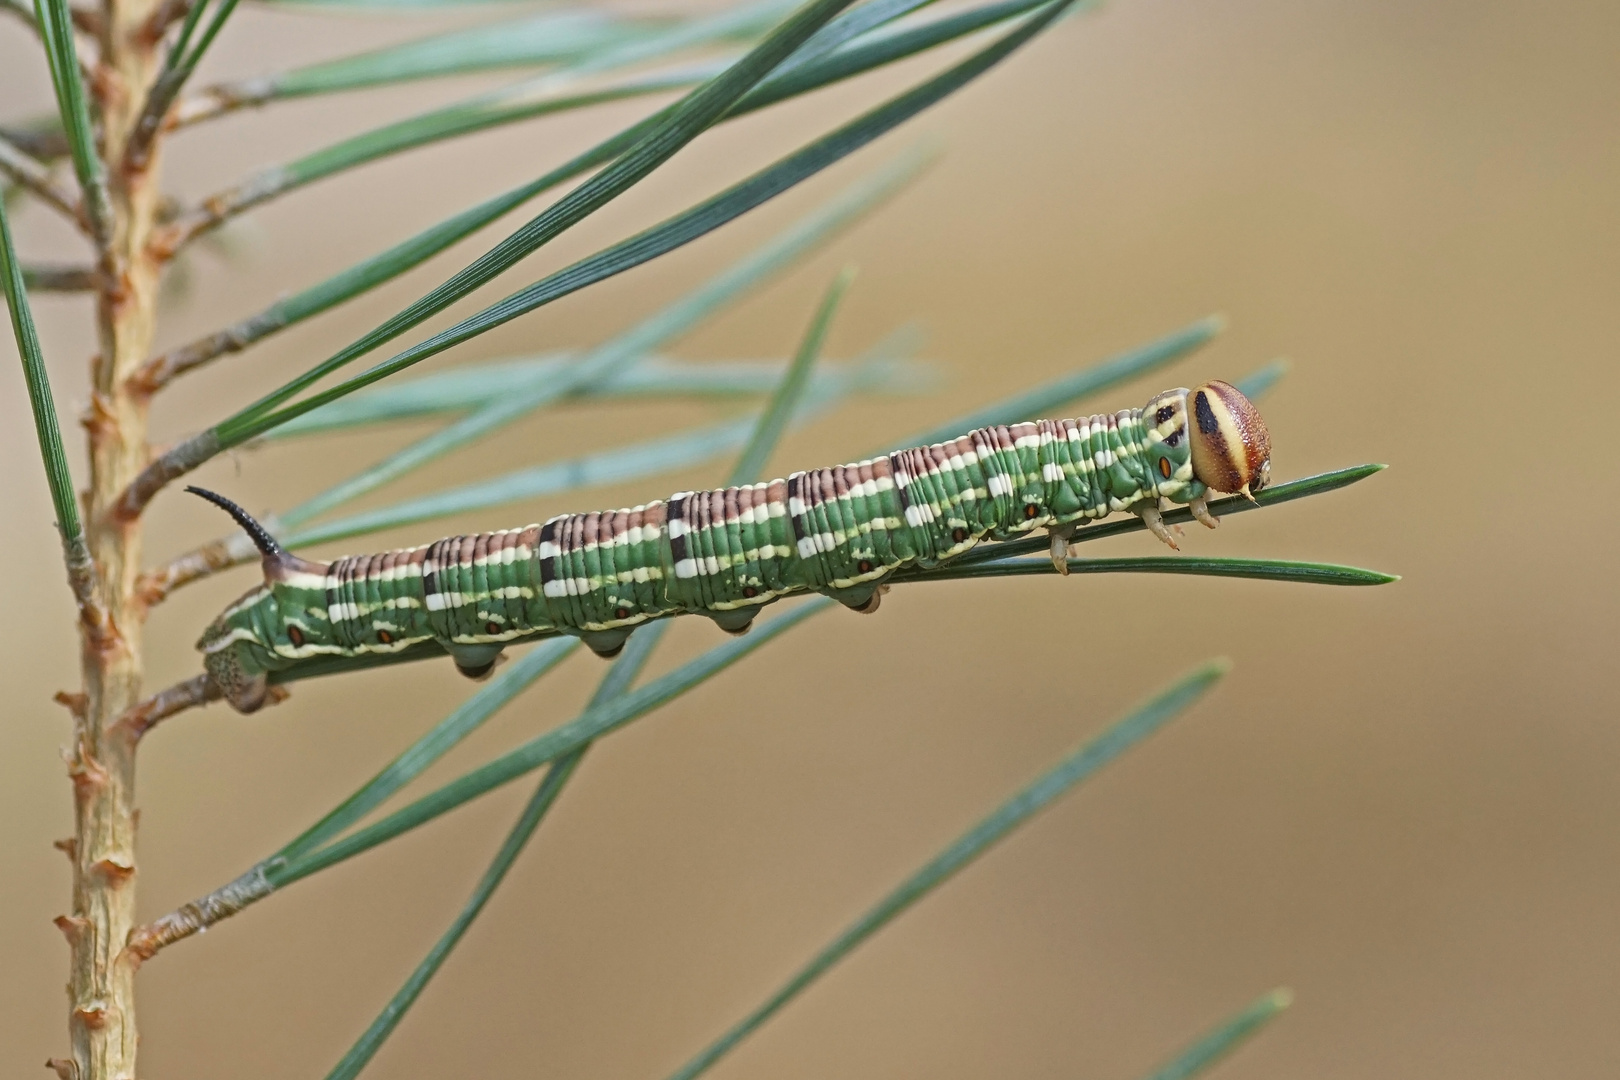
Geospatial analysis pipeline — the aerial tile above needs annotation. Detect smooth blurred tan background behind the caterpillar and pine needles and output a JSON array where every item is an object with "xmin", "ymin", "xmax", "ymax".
[{"xmin": 0, "ymin": 0, "xmax": 1620, "ymax": 1080}]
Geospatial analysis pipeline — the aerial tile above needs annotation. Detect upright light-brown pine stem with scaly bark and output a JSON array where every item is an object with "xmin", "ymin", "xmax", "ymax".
[{"xmin": 53, "ymin": 0, "xmax": 170, "ymax": 1080}]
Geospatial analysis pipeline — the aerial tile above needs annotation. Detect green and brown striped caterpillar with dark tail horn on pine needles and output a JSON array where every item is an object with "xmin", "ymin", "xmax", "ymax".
[{"xmin": 196, "ymin": 381, "xmax": 1272, "ymax": 712}]
